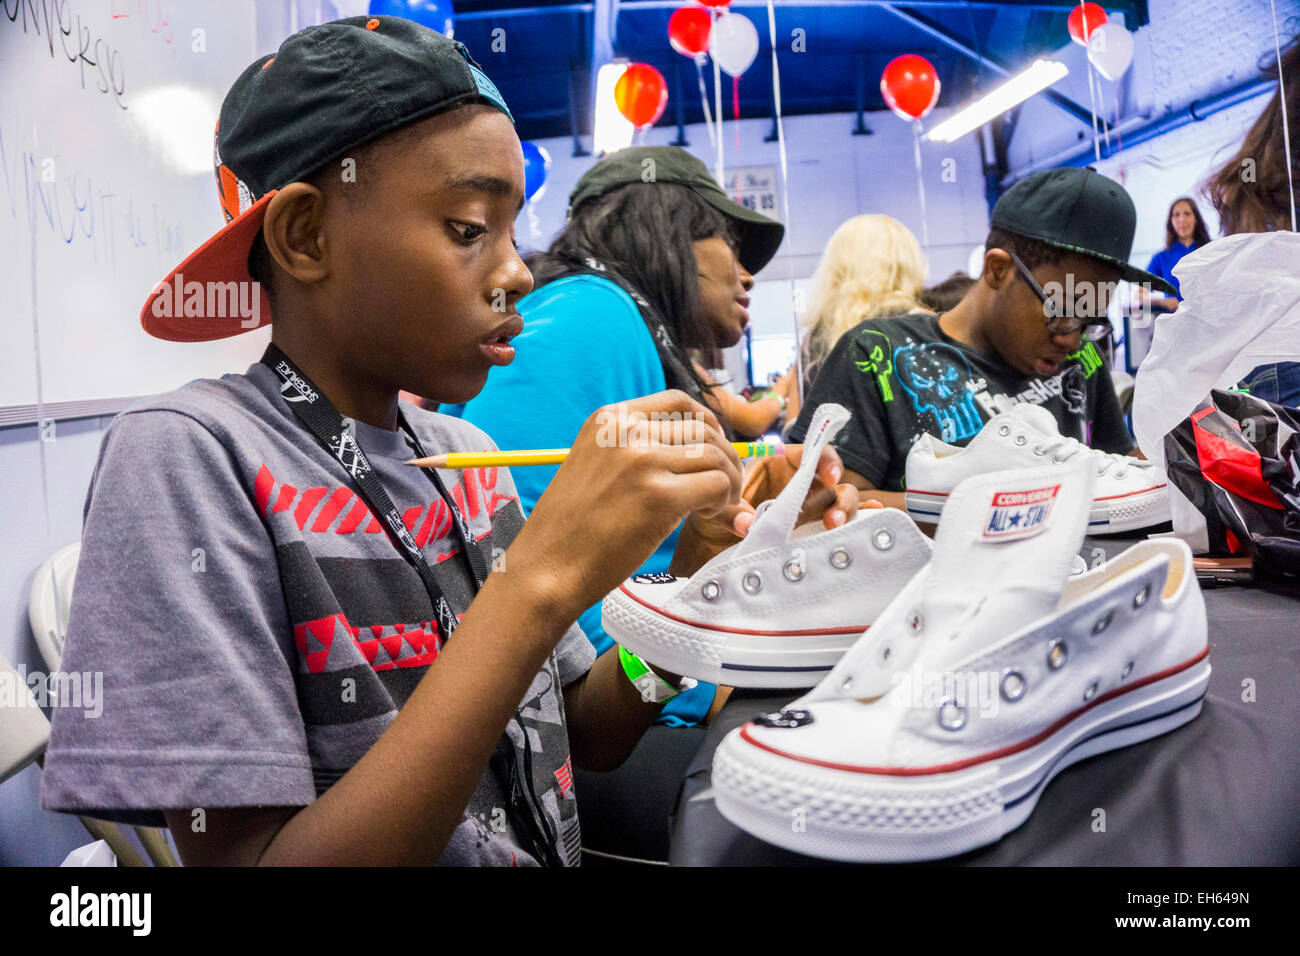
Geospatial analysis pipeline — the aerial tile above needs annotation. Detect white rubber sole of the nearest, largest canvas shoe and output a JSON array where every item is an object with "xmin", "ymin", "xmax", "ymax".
[{"xmin": 712, "ymin": 657, "xmax": 1210, "ymax": 862}]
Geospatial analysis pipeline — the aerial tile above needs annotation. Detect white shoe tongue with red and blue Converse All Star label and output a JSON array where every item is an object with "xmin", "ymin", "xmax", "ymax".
[{"xmin": 927, "ymin": 460, "xmax": 1096, "ymax": 623}]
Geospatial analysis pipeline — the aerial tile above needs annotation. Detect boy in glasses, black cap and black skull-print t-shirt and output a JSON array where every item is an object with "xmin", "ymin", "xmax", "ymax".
[{"xmin": 789, "ymin": 169, "xmax": 1169, "ymax": 509}]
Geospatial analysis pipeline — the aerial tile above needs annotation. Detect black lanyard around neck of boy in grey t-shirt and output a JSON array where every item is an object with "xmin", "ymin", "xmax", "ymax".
[{"xmin": 261, "ymin": 342, "xmax": 560, "ymax": 866}]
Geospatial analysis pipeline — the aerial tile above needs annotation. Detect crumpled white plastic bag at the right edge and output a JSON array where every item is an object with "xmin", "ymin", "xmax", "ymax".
[{"xmin": 1134, "ymin": 233, "xmax": 1300, "ymax": 551}]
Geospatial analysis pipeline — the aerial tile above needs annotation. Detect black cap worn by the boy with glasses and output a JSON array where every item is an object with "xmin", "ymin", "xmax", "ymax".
[{"xmin": 992, "ymin": 168, "xmax": 1177, "ymax": 295}]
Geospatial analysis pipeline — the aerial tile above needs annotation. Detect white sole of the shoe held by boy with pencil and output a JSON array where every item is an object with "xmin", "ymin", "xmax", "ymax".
[{"xmin": 601, "ymin": 588, "xmax": 867, "ymax": 689}]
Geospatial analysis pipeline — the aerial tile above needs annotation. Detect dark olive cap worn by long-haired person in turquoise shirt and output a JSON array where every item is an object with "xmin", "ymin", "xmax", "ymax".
[{"xmin": 568, "ymin": 146, "xmax": 785, "ymax": 273}]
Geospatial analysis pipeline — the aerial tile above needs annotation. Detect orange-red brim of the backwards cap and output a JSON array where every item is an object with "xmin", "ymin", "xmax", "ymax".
[{"xmin": 140, "ymin": 190, "xmax": 276, "ymax": 342}]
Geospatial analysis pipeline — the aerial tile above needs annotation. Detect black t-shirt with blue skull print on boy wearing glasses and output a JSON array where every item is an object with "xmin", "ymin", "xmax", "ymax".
[{"xmin": 788, "ymin": 313, "xmax": 1134, "ymax": 492}]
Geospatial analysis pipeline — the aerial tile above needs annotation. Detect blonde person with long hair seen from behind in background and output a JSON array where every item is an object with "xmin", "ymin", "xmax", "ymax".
[{"xmin": 776, "ymin": 213, "xmax": 928, "ymax": 421}]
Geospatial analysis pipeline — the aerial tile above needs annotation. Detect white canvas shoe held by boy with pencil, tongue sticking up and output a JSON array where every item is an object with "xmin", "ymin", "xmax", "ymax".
[{"xmin": 601, "ymin": 405, "xmax": 930, "ymax": 688}]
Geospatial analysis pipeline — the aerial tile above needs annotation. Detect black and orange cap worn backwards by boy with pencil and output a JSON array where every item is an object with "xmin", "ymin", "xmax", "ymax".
[{"xmin": 140, "ymin": 17, "xmax": 514, "ymax": 342}]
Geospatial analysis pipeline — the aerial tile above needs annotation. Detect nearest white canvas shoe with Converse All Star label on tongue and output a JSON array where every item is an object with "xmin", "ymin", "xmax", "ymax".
[{"xmin": 712, "ymin": 460, "xmax": 1210, "ymax": 862}]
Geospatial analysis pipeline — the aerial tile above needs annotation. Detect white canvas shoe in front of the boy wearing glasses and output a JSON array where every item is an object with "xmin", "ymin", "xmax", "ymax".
[{"xmin": 905, "ymin": 402, "xmax": 1170, "ymax": 535}]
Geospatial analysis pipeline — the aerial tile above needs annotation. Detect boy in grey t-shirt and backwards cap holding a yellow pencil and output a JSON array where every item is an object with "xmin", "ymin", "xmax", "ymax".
[{"xmin": 42, "ymin": 17, "xmax": 857, "ymax": 865}]
